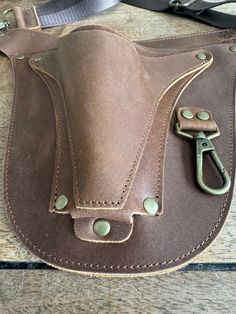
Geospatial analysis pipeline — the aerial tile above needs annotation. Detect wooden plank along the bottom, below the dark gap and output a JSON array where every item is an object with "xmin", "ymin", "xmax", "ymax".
[{"xmin": 0, "ymin": 270, "xmax": 236, "ymax": 314}]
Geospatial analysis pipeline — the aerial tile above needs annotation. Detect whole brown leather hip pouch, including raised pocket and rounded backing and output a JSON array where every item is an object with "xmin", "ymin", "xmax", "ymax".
[{"xmin": 0, "ymin": 26, "xmax": 236, "ymax": 275}]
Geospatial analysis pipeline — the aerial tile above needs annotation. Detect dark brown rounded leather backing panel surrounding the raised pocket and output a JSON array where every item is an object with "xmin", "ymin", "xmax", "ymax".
[{"xmin": 0, "ymin": 30, "xmax": 236, "ymax": 276}]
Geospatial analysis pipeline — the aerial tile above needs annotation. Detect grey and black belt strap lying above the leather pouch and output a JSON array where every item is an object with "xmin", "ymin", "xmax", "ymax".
[{"xmin": 0, "ymin": 0, "xmax": 236, "ymax": 29}]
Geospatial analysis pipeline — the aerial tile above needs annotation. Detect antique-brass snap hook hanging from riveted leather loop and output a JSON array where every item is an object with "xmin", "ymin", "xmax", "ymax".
[{"xmin": 176, "ymin": 123, "xmax": 231, "ymax": 195}]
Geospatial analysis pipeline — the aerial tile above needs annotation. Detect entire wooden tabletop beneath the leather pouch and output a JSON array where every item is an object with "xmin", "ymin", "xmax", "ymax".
[{"xmin": 0, "ymin": 0, "xmax": 236, "ymax": 314}]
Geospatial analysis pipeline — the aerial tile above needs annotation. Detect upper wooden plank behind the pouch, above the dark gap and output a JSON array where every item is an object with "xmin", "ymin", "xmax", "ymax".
[{"xmin": 0, "ymin": 0, "xmax": 236, "ymax": 263}]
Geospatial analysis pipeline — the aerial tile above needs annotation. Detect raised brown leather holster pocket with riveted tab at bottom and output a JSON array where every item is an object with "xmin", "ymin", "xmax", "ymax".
[{"xmin": 30, "ymin": 30, "xmax": 211, "ymax": 241}]
